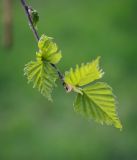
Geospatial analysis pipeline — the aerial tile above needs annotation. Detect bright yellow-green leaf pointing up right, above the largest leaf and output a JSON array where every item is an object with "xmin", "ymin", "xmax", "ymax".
[{"xmin": 65, "ymin": 57, "xmax": 103, "ymax": 86}]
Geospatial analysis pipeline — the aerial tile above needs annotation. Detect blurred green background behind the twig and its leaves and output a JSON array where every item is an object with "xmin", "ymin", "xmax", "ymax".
[{"xmin": 0, "ymin": 0, "xmax": 137, "ymax": 160}]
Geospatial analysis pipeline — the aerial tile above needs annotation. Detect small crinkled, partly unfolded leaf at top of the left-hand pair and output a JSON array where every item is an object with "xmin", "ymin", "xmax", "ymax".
[{"xmin": 37, "ymin": 35, "xmax": 62, "ymax": 64}]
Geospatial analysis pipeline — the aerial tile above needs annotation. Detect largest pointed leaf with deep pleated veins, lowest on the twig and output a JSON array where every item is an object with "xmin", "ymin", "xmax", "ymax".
[{"xmin": 74, "ymin": 82, "xmax": 122, "ymax": 129}]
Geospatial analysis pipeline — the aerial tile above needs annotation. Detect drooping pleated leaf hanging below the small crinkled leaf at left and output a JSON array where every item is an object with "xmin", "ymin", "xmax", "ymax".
[{"xmin": 24, "ymin": 60, "xmax": 57, "ymax": 101}]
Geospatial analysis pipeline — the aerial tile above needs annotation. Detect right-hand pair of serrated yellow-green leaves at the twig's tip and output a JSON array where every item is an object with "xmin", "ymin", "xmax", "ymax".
[{"xmin": 65, "ymin": 57, "xmax": 122, "ymax": 129}]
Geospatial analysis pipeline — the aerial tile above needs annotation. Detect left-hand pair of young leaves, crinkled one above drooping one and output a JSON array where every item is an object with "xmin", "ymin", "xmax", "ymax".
[{"xmin": 24, "ymin": 35, "xmax": 62, "ymax": 101}]
